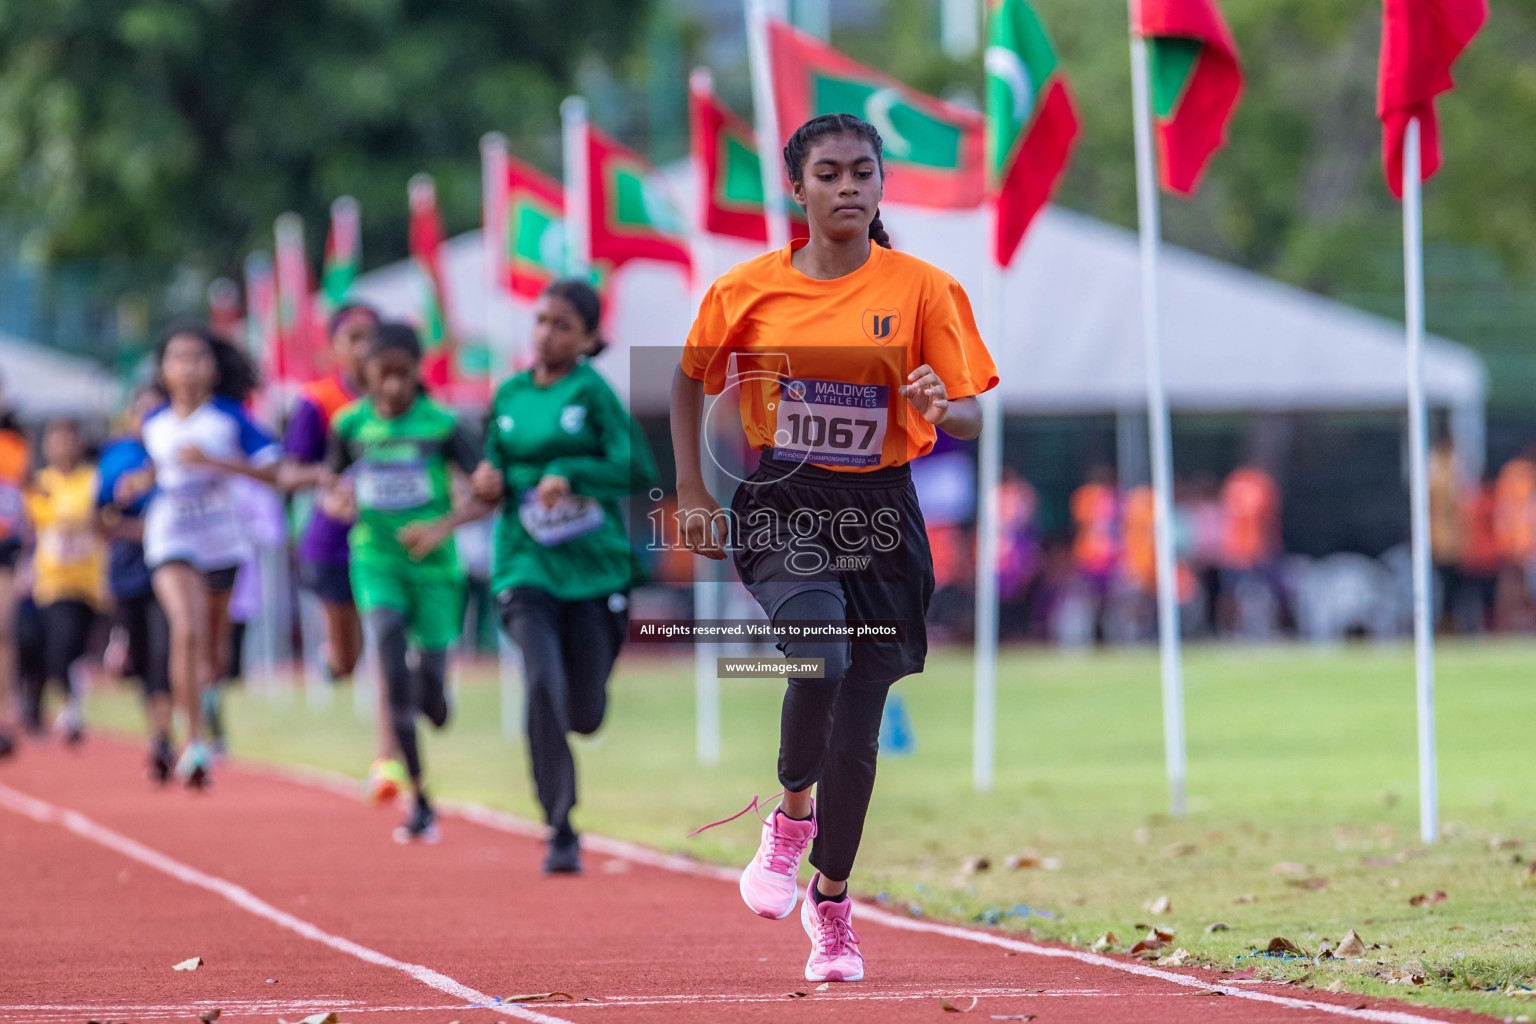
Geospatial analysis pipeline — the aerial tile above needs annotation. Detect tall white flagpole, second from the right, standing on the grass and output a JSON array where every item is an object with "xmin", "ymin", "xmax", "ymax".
[{"xmin": 1130, "ymin": 28, "xmax": 1186, "ymax": 818}]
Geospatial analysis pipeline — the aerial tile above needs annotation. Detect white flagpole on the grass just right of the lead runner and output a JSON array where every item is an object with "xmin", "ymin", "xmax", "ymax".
[{"xmin": 971, "ymin": 203, "xmax": 1003, "ymax": 792}]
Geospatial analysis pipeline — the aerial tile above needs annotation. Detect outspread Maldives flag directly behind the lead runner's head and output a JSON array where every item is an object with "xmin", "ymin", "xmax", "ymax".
[{"xmin": 768, "ymin": 20, "xmax": 986, "ymax": 207}]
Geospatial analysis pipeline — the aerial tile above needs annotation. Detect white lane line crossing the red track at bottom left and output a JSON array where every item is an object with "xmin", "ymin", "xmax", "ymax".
[{"xmin": 0, "ymin": 785, "xmax": 568, "ymax": 1024}]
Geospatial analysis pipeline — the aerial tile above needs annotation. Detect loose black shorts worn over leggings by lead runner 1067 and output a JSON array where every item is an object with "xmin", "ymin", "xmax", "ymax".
[{"xmin": 731, "ymin": 451, "xmax": 934, "ymax": 685}]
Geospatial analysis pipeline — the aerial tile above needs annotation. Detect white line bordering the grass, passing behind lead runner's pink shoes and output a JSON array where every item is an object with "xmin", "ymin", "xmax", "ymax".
[{"xmin": 230, "ymin": 763, "xmax": 1474, "ymax": 1024}]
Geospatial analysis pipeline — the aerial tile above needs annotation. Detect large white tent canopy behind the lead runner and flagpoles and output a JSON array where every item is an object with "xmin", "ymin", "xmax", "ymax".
[{"xmin": 356, "ymin": 166, "xmax": 1487, "ymax": 417}]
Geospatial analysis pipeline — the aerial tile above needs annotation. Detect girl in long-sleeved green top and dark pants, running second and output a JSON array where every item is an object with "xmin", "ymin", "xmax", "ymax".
[{"xmin": 473, "ymin": 279, "xmax": 656, "ymax": 874}]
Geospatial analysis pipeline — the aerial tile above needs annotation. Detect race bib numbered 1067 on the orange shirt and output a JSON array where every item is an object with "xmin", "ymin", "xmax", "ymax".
[{"xmin": 773, "ymin": 378, "xmax": 891, "ymax": 465}]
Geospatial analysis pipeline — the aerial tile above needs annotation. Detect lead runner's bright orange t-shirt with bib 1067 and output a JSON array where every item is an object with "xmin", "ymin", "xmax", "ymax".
[{"xmin": 682, "ymin": 238, "xmax": 997, "ymax": 473}]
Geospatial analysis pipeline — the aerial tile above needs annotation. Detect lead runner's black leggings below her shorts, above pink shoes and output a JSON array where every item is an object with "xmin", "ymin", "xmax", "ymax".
[{"xmin": 774, "ymin": 590, "xmax": 894, "ymax": 881}]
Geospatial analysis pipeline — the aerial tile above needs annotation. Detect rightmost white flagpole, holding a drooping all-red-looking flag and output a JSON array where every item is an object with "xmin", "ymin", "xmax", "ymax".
[{"xmin": 1402, "ymin": 118, "xmax": 1439, "ymax": 843}]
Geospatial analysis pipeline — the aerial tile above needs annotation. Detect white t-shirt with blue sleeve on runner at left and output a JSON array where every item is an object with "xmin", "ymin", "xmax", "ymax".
[{"xmin": 143, "ymin": 398, "xmax": 283, "ymax": 571}]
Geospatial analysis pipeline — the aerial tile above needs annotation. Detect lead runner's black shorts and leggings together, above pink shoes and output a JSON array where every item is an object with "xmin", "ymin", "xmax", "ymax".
[{"xmin": 731, "ymin": 450, "xmax": 934, "ymax": 881}]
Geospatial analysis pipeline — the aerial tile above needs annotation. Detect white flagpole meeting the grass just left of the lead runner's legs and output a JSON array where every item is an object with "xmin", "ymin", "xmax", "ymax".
[{"xmin": 694, "ymin": 68, "xmax": 722, "ymax": 765}]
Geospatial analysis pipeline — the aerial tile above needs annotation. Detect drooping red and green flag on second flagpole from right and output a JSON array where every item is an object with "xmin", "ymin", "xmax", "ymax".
[{"xmin": 1130, "ymin": 0, "xmax": 1243, "ymax": 195}]
